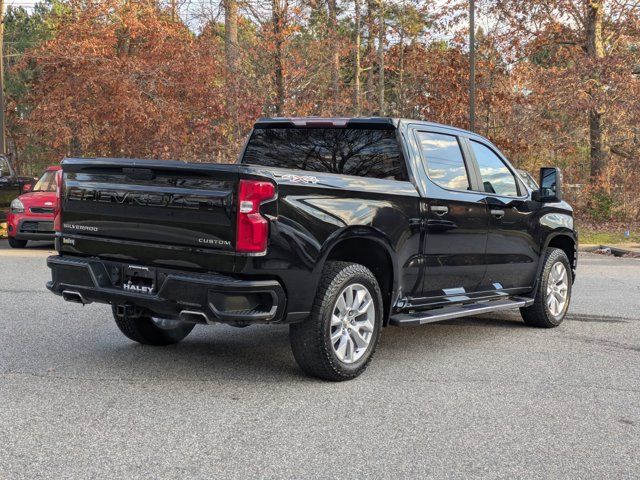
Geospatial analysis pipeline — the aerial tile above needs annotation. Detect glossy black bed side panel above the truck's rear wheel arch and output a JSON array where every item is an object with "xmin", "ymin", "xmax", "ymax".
[{"xmin": 236, "ymin": 169, "xmax": 421, "ymax": 321}]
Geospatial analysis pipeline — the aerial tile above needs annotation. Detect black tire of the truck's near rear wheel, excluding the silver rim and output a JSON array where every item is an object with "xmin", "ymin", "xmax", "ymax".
[{"xmin": 289, "ymin": 261, "xmax": 383, "ymax": 382}]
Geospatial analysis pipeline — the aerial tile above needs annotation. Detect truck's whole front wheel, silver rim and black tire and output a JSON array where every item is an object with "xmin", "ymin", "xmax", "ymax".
[{"xmin": 520, "ymin": 248, "xmax": 572, "ymax": 328}]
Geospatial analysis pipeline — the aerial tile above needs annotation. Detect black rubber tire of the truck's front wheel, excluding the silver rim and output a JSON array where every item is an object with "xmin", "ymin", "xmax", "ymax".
[{"xmin": 520, "ymin": 248, "xmax": 573, "ymax": 328}]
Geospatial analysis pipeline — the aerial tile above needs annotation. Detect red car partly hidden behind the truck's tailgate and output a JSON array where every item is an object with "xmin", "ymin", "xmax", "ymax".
[{"xmin": 7, "ymin": 166, "xmax": 60, "ymax": 248}]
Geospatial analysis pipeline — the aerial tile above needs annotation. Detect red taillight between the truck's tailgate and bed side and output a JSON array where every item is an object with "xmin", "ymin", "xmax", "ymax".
[{"xmin": 236, "ymin": 180, "xmax": 276, "ymax": 253}]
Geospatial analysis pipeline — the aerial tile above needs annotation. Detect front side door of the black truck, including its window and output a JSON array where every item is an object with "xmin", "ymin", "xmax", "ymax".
[{"xmin": 469, "ymin": 139, "xmax": 539, "ymax": 293}]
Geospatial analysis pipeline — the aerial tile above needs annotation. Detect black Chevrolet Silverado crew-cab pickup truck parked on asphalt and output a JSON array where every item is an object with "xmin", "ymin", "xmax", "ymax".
[{"xmin": 47, "ymin": 118, "xmax": 577, "ymax": 380}]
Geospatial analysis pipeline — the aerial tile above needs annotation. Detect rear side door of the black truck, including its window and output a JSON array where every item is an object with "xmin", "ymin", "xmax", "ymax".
[{"xmin": 414, "ymin": 127, "xmax": 489, "ymax": 303}]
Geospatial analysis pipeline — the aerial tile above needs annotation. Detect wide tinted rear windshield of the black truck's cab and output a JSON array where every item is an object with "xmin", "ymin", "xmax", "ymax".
[{"xmin": 242, "ymin": 127, "xmax": 408, "ymax": 181}]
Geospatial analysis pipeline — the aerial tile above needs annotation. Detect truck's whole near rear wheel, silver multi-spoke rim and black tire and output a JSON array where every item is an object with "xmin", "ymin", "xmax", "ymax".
[{"xmin": 289, "ymin": 261, "xmax": 383, "ymax": 381}]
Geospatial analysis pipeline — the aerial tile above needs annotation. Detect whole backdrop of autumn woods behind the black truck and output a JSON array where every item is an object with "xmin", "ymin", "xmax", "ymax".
[{"xmin": 5, "ymin": 0, "xmax": 640, "ymax": 222}]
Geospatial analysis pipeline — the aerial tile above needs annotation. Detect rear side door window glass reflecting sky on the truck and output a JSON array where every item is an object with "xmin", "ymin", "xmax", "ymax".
[{"xmin": 418, "ymin": 132, "xmax": 469, "ymax": 190}]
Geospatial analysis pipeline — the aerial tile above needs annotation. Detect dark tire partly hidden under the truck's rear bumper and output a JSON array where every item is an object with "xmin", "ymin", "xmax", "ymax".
[{"xmin": 113, "ymin": 307, "xmax": 195, "ymax": 346}]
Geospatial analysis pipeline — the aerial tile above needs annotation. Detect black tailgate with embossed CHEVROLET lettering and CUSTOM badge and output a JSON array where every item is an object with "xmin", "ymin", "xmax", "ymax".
[{"xmin": 62, "ymin": 159, "xmax": 239, "ymax": 252}]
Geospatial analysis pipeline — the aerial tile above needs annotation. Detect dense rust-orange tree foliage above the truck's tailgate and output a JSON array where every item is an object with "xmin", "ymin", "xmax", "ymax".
[{"xmin": 16, "ymin": 1, "xmax": 260, "ymax": 159}]
